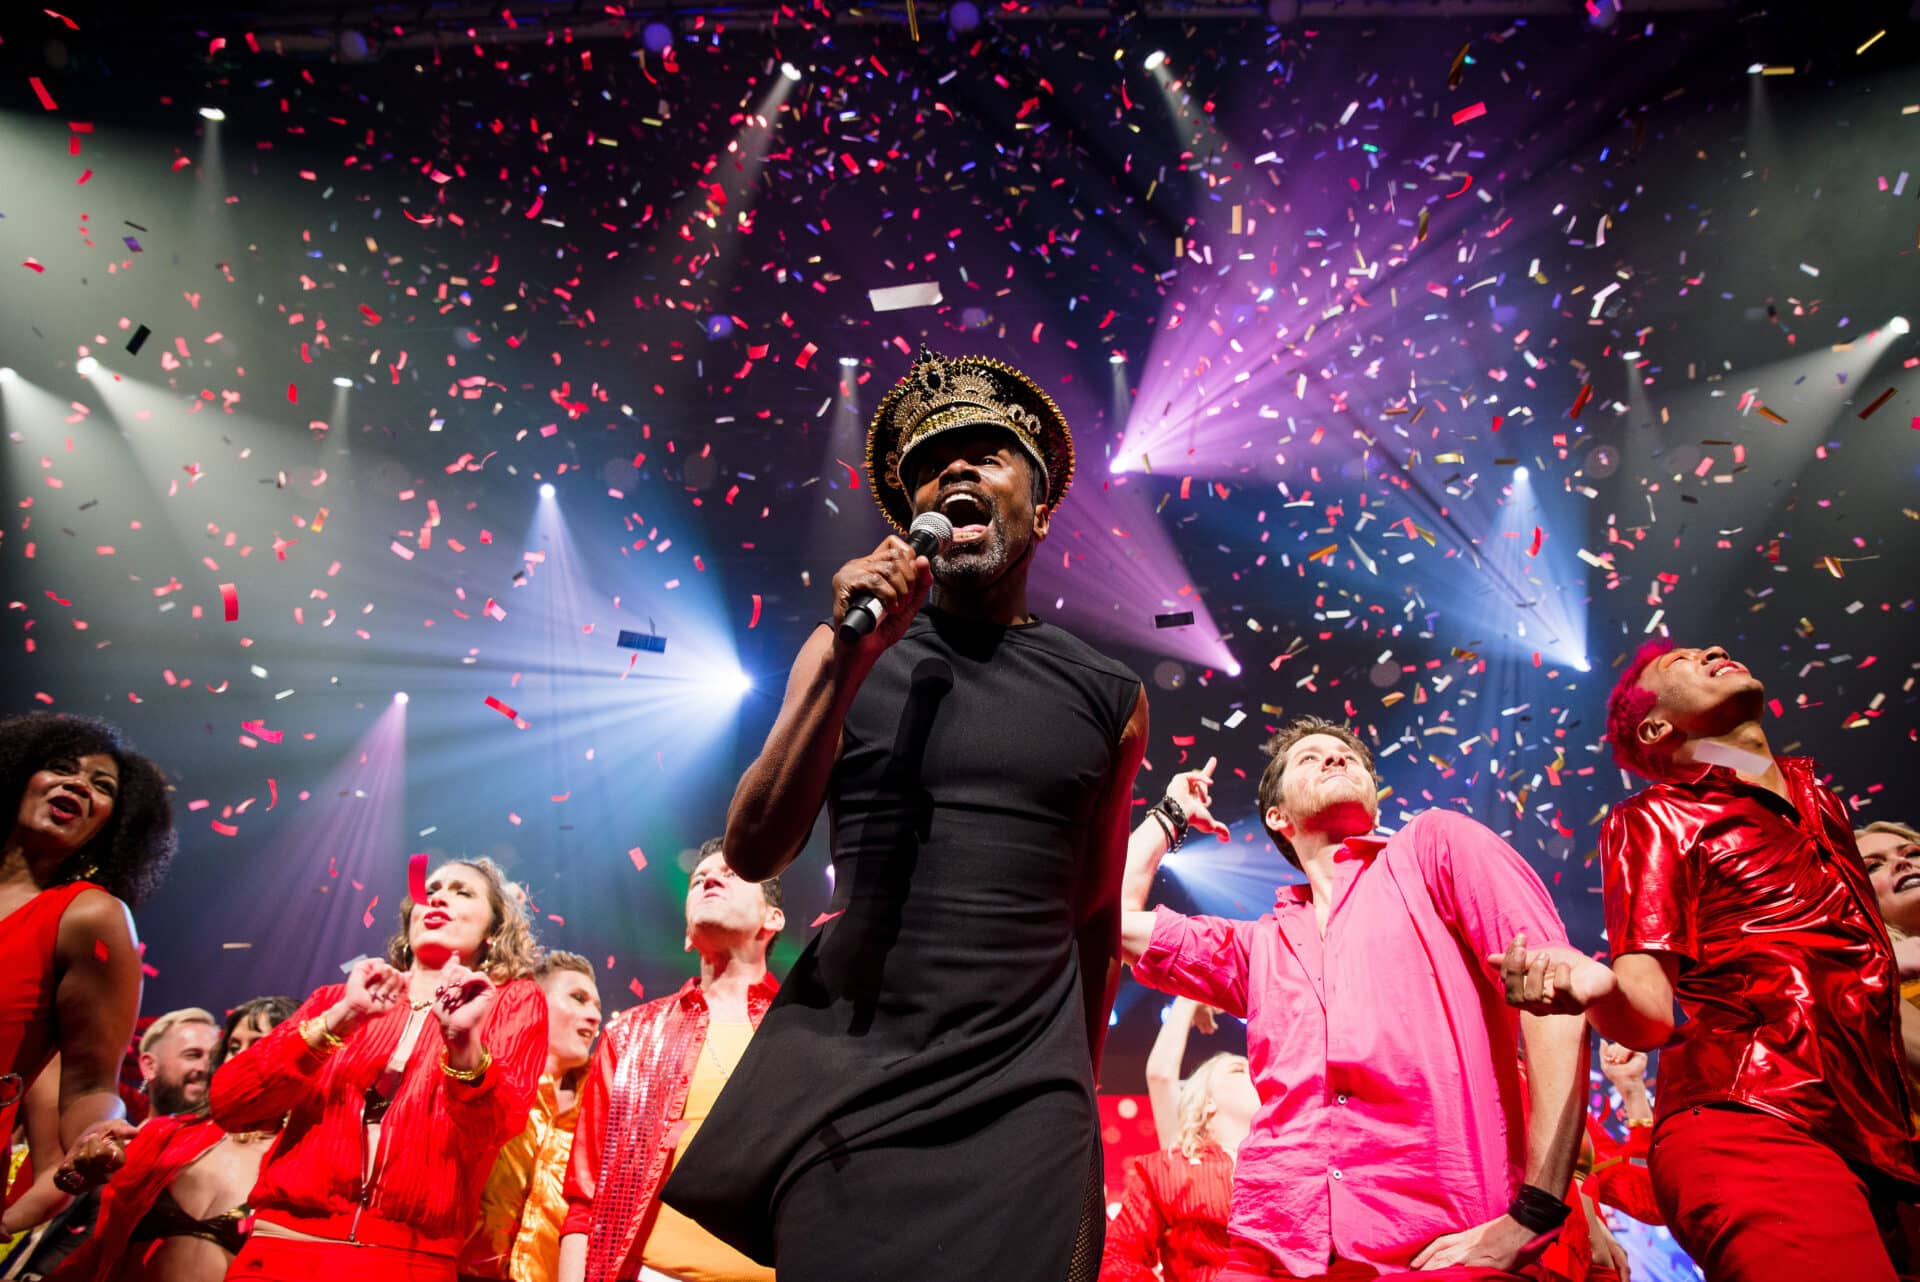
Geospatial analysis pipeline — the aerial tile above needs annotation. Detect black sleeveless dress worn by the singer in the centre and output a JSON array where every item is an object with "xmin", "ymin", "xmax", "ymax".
[{"xmin": 662, "ymin": 608, "xmax": 1140, "ymax": 1282}]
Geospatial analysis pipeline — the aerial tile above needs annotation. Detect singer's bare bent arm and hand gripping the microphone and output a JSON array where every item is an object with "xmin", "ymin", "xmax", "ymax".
[{"xmin": 726, "ymin": 537, "xmax": 933, "ymax": 881}]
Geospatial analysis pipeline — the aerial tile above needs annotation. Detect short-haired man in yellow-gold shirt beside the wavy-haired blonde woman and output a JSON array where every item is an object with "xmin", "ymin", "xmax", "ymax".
[{"xmin": 459, "ymin": 950, "xmax": 601, "ymax": 1282}]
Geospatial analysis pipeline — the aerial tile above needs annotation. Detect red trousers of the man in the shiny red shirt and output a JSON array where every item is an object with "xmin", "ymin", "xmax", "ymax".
[{"xmin": 1649, "ymin": 1105, "xmax": 1920, "ymax": 1282}]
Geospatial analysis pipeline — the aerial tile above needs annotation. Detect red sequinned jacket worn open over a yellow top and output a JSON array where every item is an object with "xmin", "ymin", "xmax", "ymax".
[{"xmin": 561, "ymin": 971, "xmax": 780, "ymax": 1282}]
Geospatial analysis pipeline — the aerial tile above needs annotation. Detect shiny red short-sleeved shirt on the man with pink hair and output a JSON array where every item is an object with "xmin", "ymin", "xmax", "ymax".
[{"xmin": 1599, "ymin": 756, "xmax": 1920, "ymax": 1182}]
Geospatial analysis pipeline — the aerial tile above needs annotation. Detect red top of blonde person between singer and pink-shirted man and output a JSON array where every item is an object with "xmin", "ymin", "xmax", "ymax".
[{"xmin": 1100, "ymin": 1144, "xmax": 1233, "ymax": 1282}]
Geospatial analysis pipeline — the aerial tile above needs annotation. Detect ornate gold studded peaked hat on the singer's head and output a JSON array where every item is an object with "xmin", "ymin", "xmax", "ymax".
[{"xmin": 866, "ymin": 344, "xmax": 1073, "ymax": 534}]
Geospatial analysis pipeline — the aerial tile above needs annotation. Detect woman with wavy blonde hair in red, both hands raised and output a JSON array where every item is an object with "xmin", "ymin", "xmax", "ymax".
[{"xmin": 213, "ymin": 860, "xmax": 547, "ymax": 1282}]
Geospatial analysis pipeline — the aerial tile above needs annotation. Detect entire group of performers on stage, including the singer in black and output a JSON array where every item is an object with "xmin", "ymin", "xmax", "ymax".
[{"xmin": 0, "ymin": 351, "xmax": 1920, "ymax": 1282}]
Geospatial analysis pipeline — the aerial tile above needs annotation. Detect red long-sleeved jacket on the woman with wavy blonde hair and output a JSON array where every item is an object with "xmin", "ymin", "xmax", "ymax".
[{"xmin": 213, "ymin": 979, "xmax": 547, "ymax": 1255}]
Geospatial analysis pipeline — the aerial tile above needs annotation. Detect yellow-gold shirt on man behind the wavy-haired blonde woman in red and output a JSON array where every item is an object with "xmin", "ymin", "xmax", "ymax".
[{"xmin": 461, "ymin": 1077, "xmax": 580, "ymax": 1282}]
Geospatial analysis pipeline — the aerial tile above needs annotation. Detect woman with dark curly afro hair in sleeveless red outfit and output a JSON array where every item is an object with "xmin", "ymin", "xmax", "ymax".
[{"xmin": 0, "ymin": 712, "xmax": 173, "ymax": 1163}]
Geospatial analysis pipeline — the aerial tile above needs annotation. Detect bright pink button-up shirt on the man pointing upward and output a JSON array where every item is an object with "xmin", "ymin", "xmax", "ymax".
[{"xmin": 1135, "ymin": 810, "xmax": 1567, "ymax": 1276}]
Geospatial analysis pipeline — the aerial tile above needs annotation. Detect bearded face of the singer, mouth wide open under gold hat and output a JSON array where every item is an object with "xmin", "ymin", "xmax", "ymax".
[{"xmin": 908, "ymin": 426, "xmax": 1052, "ymax": 593}]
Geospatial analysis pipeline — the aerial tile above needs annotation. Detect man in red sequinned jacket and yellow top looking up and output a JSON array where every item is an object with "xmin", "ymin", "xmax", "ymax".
[{"xmin": 559, "ymin": 837, "xmax": 787, "ymax": 1282}]
